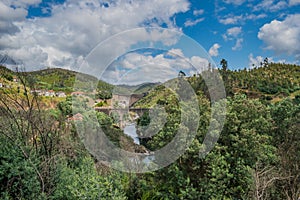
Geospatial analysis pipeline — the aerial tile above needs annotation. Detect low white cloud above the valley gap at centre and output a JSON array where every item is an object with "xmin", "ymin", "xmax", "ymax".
[{"xmin": 102, "ymin": 49, "xmax": 209, "ymax": 85}]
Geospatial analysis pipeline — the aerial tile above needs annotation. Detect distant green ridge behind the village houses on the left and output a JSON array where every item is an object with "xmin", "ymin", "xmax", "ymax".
[{"xmin": 0, "ymin": 65, "xmax": 159, "ymax": 95}]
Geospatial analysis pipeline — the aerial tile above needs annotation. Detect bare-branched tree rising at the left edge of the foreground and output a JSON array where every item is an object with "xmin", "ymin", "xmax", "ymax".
[{"xmin": 0, "ymin": 70, "xmax": 63, "ymax": 199}]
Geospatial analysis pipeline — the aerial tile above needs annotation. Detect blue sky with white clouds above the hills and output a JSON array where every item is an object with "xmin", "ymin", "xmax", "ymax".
[{"xmin": 0, "ymin": 0, "xmax": 300, "ymax": 76}]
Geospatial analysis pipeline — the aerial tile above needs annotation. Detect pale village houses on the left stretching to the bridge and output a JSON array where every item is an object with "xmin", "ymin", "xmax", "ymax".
[{"xmin": 0, "ymin": 73, "xmax": 147, "ymax": 128}]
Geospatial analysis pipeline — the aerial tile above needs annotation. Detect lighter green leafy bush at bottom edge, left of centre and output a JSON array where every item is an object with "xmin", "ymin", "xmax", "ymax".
[{"xmin": 51, "ymin": 157, "xmax": 127, "ymax": 200}]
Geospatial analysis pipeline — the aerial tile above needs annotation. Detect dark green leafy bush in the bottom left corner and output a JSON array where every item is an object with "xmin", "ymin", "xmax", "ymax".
[{"xmin": 0, "ymin": 134, "xmax": 43, "ymax": 199}]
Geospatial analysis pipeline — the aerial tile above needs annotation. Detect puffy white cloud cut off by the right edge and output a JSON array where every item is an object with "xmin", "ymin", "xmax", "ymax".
[{"xmin": 258, "ymin": 14, "xmax": 300, "ymax": 59}]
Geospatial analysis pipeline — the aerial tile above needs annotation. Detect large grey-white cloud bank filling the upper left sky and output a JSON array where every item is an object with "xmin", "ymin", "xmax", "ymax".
[{"xmin": 0, "ymin": 0, "xmax": 189, "ymax": 68}]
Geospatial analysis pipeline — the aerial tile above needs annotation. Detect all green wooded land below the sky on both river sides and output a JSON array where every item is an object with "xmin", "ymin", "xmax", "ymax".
[{"xmin": 0, "ymin": 63, "xmax": 300, "ymax": 200}]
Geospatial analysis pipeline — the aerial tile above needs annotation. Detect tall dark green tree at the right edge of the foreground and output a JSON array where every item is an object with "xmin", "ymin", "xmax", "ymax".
[{"xmin": 271, "ymin": 99, "xmax": 300, "ymax": 199}]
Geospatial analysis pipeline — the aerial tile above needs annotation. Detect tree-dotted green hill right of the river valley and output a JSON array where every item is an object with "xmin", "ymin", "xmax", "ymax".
[{"xmin": 135, "ymin": 63, "xmax": 300, "ymax": 107}]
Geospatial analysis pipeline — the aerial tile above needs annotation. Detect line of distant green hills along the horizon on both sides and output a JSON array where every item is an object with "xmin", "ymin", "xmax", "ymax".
[{"xmin": 0, "ymin": 62, "xmax": 300, "ymax": 101}]
